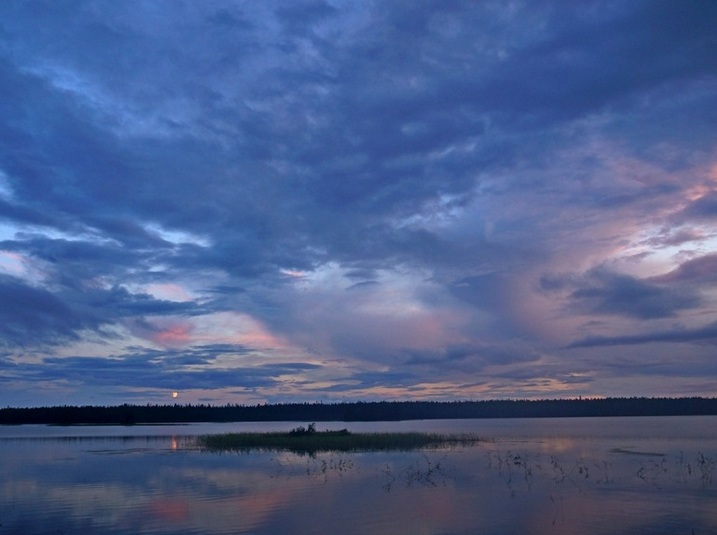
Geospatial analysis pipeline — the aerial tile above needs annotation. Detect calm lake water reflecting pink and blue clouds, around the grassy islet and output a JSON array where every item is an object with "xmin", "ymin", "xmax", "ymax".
[{"xmin": 0, "ymin": 416, "xmax": 717, "ymax": 535}]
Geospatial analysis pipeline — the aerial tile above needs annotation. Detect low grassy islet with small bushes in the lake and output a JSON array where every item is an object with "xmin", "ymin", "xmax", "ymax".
[{"xmin": 197, "ymin": 424, "xmax": 479, "ymax": 454}]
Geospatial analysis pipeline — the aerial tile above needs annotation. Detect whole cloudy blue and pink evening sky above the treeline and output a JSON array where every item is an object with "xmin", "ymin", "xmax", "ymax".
[{"xmin": 0, "ymin": 0, "xmax": 717, "ymax": 406}]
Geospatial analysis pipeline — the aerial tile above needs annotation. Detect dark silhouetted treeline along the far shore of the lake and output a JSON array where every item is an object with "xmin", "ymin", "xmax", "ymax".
[{"xmin": 0, "ymin": 397, "xmax": 717, "ymax": 425}]
